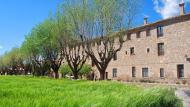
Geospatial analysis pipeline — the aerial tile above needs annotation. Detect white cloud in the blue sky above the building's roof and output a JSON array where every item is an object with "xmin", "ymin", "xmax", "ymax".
[{"xmin": 153, "ymin": 0, "xmax": 190, "ymax": 19}]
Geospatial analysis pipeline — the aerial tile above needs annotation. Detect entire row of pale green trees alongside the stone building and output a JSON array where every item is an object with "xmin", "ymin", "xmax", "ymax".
[{"xmin": 0, "ymin": 0, "xmax": 140, "ymax": 80}]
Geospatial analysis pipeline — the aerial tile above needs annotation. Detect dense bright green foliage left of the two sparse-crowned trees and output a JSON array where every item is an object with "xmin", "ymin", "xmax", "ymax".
[{"xmin": 22, "ymin": 15, "xmax": 69, "ymax": 58}]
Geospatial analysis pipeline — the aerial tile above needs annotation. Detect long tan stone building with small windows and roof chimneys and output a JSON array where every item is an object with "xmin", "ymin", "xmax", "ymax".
[{"xmin": 91, "ymin": 3, "xmax": 190, "ymax": 82}]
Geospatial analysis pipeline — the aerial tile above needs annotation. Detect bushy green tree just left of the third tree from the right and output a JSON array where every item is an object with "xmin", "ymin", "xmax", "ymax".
[{"xmin": 21, "ymin": 28, "xmax": 49, "ymax": 76}]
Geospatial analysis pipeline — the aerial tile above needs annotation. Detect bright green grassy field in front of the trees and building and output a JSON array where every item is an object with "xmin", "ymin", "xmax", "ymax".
[{"xmin": 0, "ymin": 76, "xmax": 182, "ymax": 107}]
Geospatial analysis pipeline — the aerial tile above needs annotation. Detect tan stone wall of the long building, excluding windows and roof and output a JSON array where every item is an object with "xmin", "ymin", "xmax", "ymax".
[{"xmin": 89, "ymin": 15, "xmax": 190, "ymax": 82}]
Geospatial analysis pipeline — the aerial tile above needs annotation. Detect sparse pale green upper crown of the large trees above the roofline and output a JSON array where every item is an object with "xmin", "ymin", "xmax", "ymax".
[{"xmin": 62, "ymin": 0, "xmax": 141, "ymax": 37}]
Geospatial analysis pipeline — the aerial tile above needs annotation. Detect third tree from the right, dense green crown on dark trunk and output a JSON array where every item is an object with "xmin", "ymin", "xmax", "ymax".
[{"xmin": 34, "ymin": 19, "xmax": 64, "ymax": 78}]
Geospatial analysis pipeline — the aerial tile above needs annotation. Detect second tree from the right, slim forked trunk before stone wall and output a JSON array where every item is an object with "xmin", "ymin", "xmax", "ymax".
[{"xmin": 57, "ymin": 2, "xmax": 88, "ymax": 79}]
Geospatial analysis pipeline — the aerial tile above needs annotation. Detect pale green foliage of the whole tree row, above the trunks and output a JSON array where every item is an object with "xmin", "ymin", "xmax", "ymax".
[{"xmin": 0, "ymin": 0, "xmax": 140, "ymax": 77}]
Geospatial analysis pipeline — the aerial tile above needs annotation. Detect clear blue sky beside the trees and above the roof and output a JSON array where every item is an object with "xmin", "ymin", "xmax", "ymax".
[{"xmin": 0, "ymin": 0, "xmax": 190, "ymax": 55}]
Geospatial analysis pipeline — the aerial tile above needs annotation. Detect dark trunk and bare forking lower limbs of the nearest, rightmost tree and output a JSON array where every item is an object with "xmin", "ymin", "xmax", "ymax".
[{"xmin": 86, "ymin": 34, "xmax": 124, "ymax": 80}]
